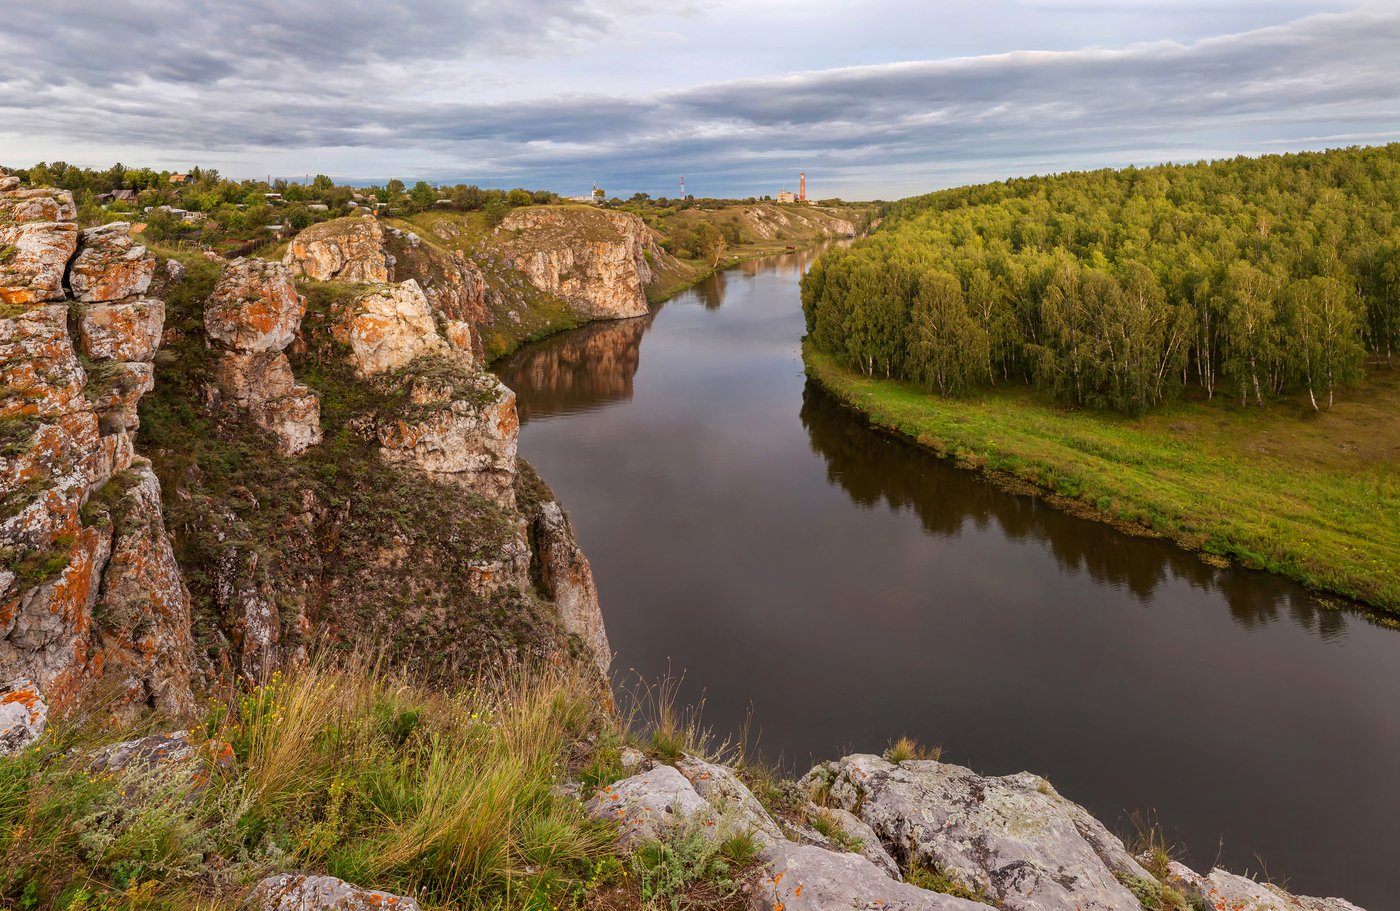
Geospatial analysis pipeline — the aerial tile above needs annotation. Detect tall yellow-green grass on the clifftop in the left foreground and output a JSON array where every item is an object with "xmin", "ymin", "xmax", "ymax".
[{"xmin": 0, "ymin": 661, "xmax": 613, "ymax": 910}]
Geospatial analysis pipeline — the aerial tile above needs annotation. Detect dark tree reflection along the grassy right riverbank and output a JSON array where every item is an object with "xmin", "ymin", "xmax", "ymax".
[{"xmin": 801, "ymin": 382, "xmax": 1361, "ymax": 640}]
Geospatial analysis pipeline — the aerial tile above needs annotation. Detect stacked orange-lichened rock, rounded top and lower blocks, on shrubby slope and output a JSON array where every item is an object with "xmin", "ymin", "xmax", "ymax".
[{"xmin": 204, "ymin": 259, "xmax": 321, "ymax": 456}]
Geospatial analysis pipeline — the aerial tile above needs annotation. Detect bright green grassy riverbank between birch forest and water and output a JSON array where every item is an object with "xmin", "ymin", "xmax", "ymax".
[{"xmin": 804, "ymin": 343, "xmax": 1400, "ymax": 614}]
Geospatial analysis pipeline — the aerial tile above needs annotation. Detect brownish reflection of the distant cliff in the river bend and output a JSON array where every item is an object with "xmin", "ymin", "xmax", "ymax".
[{"xmin": 498, "ymin": 311, "xmax": 657, "ymax": 423}]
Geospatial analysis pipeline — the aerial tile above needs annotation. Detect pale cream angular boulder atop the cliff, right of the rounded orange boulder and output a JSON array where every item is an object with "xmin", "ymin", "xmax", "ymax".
[{"xmin": 330, "ymin": 278, "xmax": 452, "ymax": 376}]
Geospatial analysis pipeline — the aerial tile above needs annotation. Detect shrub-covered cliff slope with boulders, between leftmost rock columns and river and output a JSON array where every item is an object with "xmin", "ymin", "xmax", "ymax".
[{"xmin": 130, "ymin": 209, "xmax": 609, "ymax": 680}]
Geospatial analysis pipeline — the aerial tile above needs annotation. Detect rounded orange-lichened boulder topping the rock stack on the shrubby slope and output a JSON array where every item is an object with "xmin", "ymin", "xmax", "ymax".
[{"xmin": 204, "ymin": 257, "xmax": 307, "ymax": 354}]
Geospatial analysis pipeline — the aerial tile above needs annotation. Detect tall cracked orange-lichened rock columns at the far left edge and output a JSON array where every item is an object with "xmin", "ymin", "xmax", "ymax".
[{"xmin": 0, "ymin": 176, "xmax": 193, "ymax": 714}]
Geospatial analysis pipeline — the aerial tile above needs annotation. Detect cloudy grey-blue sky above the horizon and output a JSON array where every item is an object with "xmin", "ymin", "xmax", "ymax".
[{"xmin": 0, "ymin": 0, "xmax": 1400, "ymax": 199}]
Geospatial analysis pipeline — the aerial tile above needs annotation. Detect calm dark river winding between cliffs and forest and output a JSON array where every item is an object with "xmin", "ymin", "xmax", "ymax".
[{"xmin": 498, "ymin": 246, "xmax": 1400, "ymax": 911}]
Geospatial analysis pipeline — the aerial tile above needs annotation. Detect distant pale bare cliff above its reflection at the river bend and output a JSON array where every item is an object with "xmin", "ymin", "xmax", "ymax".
[{"xmin": 493, "ymin": 206, "xmax": 665, "ymax": 319}]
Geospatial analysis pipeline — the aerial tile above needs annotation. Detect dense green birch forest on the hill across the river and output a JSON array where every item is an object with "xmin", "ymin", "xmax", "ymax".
[{"xmin": 802, "ymin": 144, "xmax": 1400, "ymax": 413}]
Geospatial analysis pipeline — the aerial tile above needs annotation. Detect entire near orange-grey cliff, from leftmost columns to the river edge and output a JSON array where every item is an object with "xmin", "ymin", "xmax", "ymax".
[{"xmin": 0, "ymin": 187, "xmax": 610, "ymax": 746}]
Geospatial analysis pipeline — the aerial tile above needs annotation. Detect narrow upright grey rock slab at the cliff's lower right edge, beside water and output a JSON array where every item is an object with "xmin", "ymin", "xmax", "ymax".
[{"xmin": 531, "ymin": 500, "xmax": 610, "ymax": 674}]
